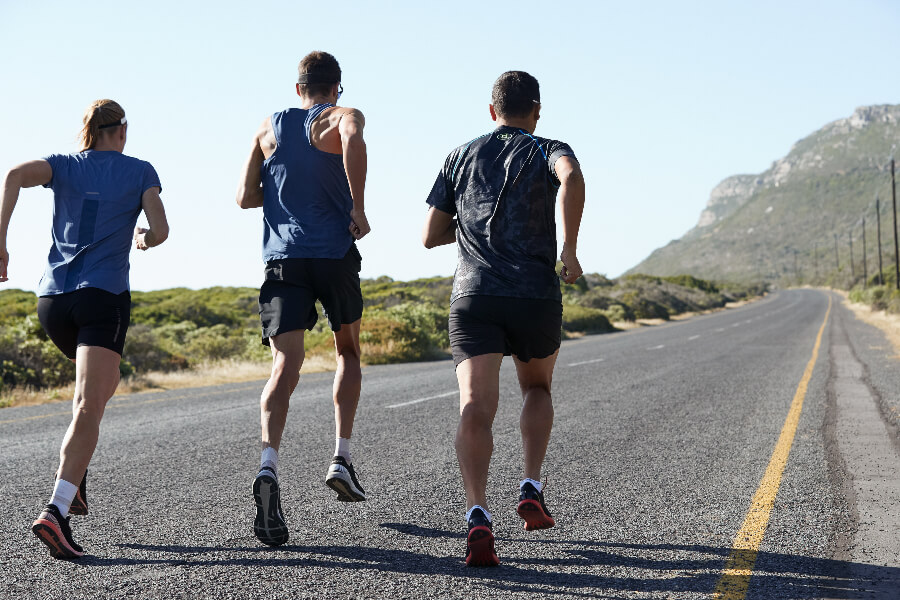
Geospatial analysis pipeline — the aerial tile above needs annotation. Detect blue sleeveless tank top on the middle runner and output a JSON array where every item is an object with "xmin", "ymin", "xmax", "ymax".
[{"xmin": 260, "ymin": 104, "xmax": 353, "ymax": 262}]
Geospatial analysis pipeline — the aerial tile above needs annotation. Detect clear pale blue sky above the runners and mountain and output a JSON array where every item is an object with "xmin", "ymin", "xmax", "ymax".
[{"xmin": 0, "ymin": 0, "xmax": 900, "ymax": 290}]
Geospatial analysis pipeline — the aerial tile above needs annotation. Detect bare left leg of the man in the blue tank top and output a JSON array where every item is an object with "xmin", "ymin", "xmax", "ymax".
[{"xmin": 259, "ymin": 329, "xmax": 306, "ymax": 451}]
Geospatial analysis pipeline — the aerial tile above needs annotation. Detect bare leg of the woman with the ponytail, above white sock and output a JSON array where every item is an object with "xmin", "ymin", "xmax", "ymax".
[{"xmin": 58, "ymin": 346, "xmax": 122, "ymax": 485}]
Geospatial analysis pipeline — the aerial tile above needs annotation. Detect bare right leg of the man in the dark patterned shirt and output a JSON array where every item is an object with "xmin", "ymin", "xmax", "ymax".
[{"xmin": 515, "ymin": 350, "xmax": 559, "ymax": 481}]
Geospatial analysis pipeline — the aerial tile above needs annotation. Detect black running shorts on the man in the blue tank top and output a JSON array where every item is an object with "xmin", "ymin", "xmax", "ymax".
[{"xmin": 259, "ymin": 244, "xmax": 363, "ymax": 346}]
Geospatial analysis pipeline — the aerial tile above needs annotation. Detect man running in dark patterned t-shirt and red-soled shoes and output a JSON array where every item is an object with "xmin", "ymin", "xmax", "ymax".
[{"xmin": 422, "ymin": 71, "xmax": 584, "ymax": 567}]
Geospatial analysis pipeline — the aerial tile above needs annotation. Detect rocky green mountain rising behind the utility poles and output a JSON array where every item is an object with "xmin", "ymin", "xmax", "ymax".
[{"xmin": 628, "ymin": 105, "xmax": 900, "ymax": 283}]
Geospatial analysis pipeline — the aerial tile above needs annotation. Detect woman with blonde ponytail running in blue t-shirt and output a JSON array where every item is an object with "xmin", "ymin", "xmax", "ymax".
[{"xmin": 0, "ymin": 100, "xmax": 169, "ymax": 558}]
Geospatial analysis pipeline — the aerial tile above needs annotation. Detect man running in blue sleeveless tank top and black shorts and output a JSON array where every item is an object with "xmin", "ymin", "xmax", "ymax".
[{"xmin": 237, "ymin": 52, "xmax": 369, "ymax": 546}]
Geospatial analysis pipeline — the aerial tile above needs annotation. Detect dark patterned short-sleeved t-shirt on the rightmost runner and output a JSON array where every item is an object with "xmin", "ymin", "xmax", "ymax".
[{"xmin": 426, "ymin": 126, "xmax": 575, "ymax": 304}]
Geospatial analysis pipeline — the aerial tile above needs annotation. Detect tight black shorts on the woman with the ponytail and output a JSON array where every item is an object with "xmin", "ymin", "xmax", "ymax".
[{"xmin": 38, "ymin": 288, "xmax": 131, "ymax": 359}]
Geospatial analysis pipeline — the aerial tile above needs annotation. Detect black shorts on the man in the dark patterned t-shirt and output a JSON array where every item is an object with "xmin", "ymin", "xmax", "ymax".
[{"xmin": 449, "ymin": 296, "xmax": 562, "ymax": 366}]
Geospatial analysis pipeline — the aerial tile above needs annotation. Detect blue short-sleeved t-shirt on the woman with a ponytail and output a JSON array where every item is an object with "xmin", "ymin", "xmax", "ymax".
[{"xmin": 38, "ymin": 150, "xmax": 162, "ymax": 296}]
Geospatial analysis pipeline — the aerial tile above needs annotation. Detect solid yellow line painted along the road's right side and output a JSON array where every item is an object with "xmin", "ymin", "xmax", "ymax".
[{"xmin": 713, "ymin": 296, "xmax": 831, "ymax": 600}]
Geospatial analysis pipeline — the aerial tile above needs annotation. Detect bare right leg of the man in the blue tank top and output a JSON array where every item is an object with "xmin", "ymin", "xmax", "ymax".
[{"xmin": 332, "ymin": 319, "xmax": 362, "ymax": 439}]
